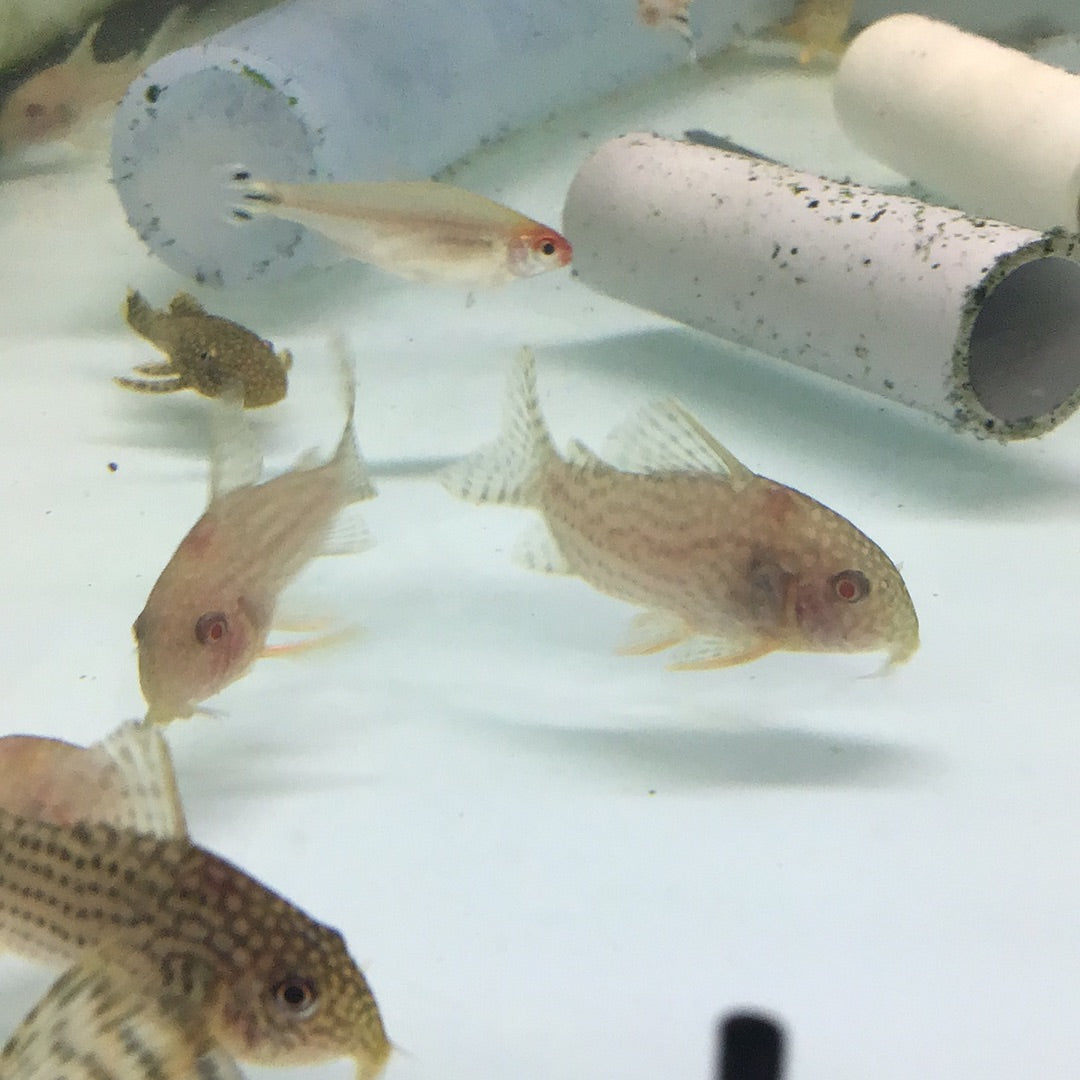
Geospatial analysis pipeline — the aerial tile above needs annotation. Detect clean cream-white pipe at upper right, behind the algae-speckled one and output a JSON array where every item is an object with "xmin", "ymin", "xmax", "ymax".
[{"xmin": 833, "ymin": 15, "xmax": 1080, "ymax": 230}]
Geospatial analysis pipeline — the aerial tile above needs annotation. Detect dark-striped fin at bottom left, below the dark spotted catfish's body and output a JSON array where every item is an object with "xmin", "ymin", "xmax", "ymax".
[{"xmin": 0, "ymin": 961, "xmax": 227, "ymax": 1080}]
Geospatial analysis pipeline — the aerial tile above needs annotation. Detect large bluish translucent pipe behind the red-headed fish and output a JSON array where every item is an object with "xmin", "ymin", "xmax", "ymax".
[{"xmin": 112, "ymin": 0, "xmax": 791, "ymax": 284}]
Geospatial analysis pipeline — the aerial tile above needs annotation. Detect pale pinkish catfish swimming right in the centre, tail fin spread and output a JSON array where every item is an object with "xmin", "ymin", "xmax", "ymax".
[{"xmin": 443, "ymin": 350, "xmax": 919, "ymax": 670}]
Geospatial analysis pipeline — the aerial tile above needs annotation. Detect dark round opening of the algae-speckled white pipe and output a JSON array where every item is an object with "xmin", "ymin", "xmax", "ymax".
[{"xmin": 968, "ymin": 257, "xmax": 1080, "ymax": 423}]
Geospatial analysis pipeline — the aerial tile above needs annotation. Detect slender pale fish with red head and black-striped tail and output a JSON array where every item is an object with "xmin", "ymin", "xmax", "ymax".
[{"xmin": 233, "ymin": 172, "xmax": 571, "ymax": 288}]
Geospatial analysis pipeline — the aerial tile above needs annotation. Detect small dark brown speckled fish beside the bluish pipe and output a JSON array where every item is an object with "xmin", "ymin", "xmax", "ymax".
[{"xmin": 114, "ymin": 289, "xmax": 293, "ymax": 408}]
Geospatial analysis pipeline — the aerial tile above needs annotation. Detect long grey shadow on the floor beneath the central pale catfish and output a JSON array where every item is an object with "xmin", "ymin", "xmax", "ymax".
[{"xmin": 481, "ymin": 720, "xmax": 941, "ymax": 794}]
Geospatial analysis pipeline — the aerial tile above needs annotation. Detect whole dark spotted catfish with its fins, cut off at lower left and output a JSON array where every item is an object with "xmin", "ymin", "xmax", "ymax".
[{"xmin": 0, "ymin": 724, "xmax": 390, "ymax": 1080}]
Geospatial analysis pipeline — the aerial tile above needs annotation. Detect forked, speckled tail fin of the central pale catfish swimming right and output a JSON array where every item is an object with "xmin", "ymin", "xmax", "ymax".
[{"xmin": 440, "ymin": 348, "xmax": 558, "ymax": 507}]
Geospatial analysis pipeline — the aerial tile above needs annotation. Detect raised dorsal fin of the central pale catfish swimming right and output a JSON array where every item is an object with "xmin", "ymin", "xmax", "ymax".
[{"xmin": 604, "ymin": 397, "xmax": 754, "ymax": 488}]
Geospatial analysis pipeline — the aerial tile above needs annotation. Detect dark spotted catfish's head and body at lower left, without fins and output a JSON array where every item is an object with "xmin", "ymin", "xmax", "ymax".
[{"xmin": 0, "ymin": 811, "xmax": 390, "ymax": 1076}]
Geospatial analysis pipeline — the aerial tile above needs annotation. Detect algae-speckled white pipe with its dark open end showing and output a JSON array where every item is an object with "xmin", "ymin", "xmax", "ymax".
[{"xmin": 564, "ymin": 134, "xmax": 1080, "ymax": 440}]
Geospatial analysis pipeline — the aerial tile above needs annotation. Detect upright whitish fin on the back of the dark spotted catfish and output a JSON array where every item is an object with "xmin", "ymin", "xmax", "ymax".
[{"xmin": 94, "ymin": 721, "xmax": 188, "ymax": 838}]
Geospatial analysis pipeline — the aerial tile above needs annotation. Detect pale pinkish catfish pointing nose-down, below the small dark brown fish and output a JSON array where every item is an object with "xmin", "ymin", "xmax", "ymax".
[{"xmin": 133, "ymin": 343, "xmax": 375, "ymax": 723}]
